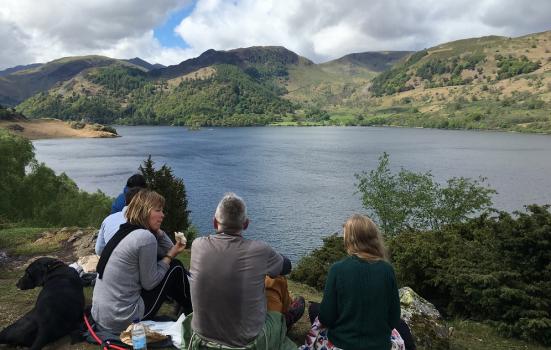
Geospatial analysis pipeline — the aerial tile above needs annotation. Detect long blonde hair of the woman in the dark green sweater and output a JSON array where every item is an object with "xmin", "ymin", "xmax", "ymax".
[{"xmin": 343, "ymin": 214, "xmax": 387, "ymax": 261}]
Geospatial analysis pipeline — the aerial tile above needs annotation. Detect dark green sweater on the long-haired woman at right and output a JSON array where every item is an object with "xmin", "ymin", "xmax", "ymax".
[{"xmin": 319, "ymin": 256, "xmax": 400, "ymax": 350}]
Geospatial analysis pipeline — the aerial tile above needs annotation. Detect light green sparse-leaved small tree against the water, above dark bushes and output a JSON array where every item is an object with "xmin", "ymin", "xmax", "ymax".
[{"xmin": 355, "ymin": 153, "xmax": 496, "ymax": 235}]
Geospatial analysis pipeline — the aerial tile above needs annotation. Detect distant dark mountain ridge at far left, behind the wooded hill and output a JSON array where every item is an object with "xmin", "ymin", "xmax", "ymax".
[{"xmin": 0, "ymin": 56, "xmax": 147, "ymax": 106}]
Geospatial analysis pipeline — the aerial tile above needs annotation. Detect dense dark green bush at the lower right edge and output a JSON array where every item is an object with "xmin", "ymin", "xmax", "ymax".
[{"xmin": 389, "ymin": 205, "xmax": 551, "ymax": 345}]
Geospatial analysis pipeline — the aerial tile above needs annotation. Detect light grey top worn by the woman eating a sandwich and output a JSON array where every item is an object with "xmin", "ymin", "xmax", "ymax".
[{"xmin": 92, "ymin": 229, "xmax": 173, "ymax": 333}]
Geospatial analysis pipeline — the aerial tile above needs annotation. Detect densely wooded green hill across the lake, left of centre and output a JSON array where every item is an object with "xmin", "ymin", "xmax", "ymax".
[{"xmin": 18, "ymin": 47, "xmax": 320, "ymax": 125}]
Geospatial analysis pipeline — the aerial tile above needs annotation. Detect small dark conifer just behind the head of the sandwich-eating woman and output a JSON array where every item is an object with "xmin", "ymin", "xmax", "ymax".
[{"xmin": 139, "ymin": 155, "xmax": 190, "ymax": 238}]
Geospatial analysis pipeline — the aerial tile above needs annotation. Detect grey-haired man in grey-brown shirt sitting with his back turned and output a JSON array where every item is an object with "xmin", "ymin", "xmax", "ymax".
[{"xmin": 188, "ymin": 193, "xmax": 304, "ymax": 350}]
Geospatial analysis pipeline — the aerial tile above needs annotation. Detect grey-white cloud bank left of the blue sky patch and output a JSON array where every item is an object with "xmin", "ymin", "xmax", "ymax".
[{"xmin": 0, "ymin": 0, "xmax": 191, "ymax": 69}]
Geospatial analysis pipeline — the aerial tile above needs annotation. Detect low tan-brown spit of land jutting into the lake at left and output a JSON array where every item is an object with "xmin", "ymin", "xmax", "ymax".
[{"xmin": 0, "ymin": 118, "xmax": 119, "ymax": 140}]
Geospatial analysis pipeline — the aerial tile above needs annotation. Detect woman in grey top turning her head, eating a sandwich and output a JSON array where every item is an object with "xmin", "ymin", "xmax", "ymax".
[{"xmin": 92, "ymin": 190, "xmax": 192, "ymax": 334}]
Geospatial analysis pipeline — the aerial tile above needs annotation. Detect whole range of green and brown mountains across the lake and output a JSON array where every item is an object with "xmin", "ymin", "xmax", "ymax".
[{"xmin": 6, "ymin": 32, "xmax": 551, "ymax": 132}]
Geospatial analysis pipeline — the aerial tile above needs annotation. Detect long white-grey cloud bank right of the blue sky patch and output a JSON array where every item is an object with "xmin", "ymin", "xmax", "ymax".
[{"xmin": 176, "ymin": 0, "xmax": 551, "ymax": 61}]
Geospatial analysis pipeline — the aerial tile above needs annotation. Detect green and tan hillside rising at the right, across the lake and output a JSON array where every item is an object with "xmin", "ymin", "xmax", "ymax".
[{"xmin": 339, "ymin": 32, "xmax": 551, "ymax": 133}]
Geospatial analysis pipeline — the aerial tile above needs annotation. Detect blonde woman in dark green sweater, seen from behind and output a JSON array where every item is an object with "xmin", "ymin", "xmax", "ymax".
[{"xmin": 301, "ymin": 214, "xmax": 403, "ymax": 350}]
